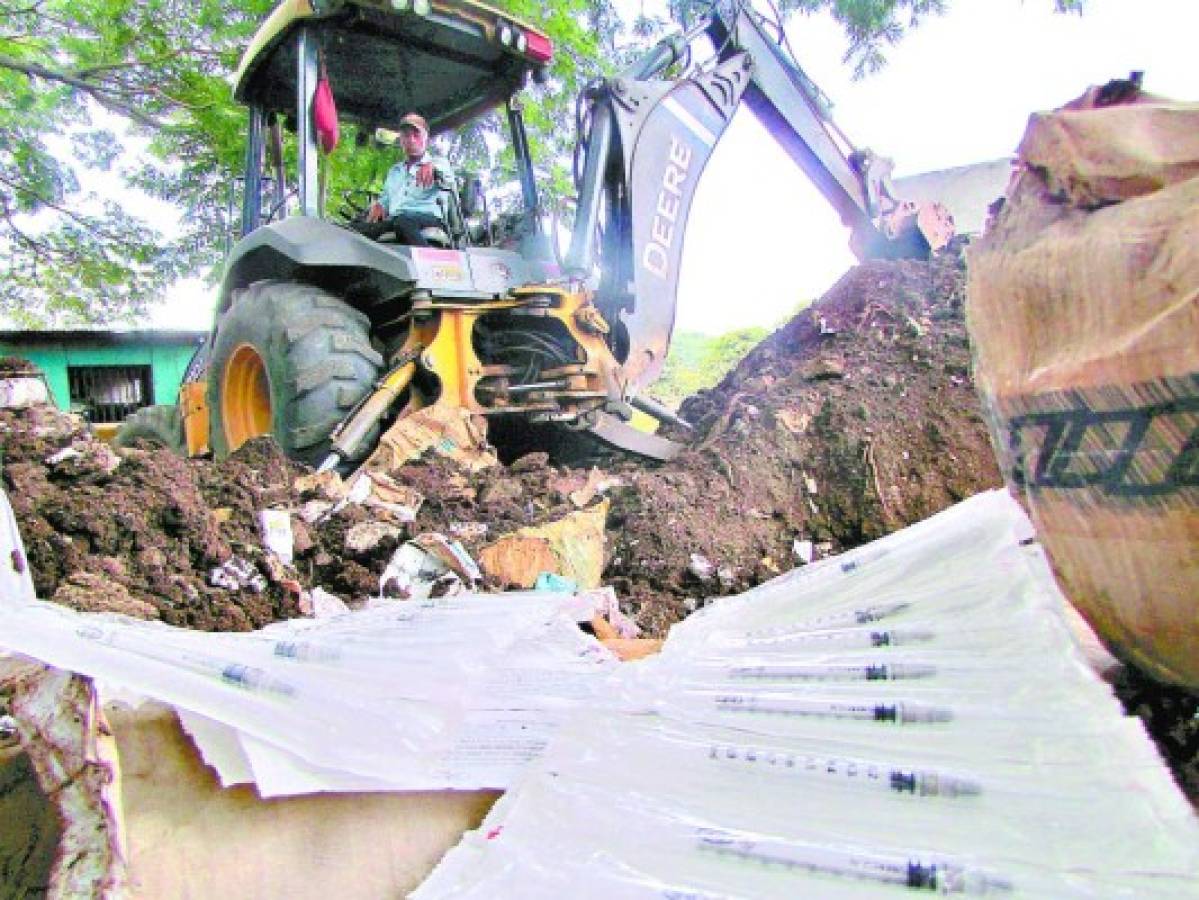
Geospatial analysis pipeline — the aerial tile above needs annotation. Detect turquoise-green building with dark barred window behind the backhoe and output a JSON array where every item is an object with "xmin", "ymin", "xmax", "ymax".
[{"xmin": 0, "ymin": 330, "xmax": 207, "ymax": 424}]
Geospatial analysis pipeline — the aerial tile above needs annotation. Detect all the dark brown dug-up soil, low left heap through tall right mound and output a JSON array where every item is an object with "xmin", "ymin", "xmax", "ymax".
[{"xmin": 0, "ymin": 244, "xmax": 1199, "ymax": 798}]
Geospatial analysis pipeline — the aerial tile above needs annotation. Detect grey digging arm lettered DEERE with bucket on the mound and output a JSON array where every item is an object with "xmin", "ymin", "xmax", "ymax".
[{"xmin": 566, "ymin": 0, "xmax": 952, "ymax": 400}]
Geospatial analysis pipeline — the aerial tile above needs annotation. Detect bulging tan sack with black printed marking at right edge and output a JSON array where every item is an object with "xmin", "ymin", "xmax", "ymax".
[{"xmin": 968, "ymin": 90, "xmax": 1199, "ymax": 690}]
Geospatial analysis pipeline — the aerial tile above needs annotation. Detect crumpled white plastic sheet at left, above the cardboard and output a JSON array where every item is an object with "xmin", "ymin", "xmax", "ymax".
[{"xmin": 0, "ymin": 580, "xmax": 616, "ymax": 796}]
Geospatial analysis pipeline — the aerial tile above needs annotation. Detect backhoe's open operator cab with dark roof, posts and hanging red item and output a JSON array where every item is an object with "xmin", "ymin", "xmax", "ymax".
[{"xmin": 234, "ymin": 0, "xmax": 553, "ymax": 249}]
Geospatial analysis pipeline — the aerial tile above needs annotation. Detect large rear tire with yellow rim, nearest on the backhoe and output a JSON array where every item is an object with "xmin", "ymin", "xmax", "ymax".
[{"xmin": 207, "ymin": 282, "xmax": 382, "ymax": 465}]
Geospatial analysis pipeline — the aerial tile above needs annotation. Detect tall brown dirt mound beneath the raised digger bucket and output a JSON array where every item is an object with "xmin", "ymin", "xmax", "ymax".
[{"xmin": 605, "ymin": 244, "xmax": 1001, "ymax": 633}]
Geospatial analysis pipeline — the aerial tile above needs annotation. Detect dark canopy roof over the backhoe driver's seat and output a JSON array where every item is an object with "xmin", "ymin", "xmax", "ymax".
[{"xmin": 234, "ymin": 0, "xmax": 553, "ymax": 132}]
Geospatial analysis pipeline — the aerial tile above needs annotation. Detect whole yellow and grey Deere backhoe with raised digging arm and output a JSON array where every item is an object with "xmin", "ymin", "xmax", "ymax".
[{"xmin": 118, "ymin": 0, "xmax": 952, "ymax": 470}]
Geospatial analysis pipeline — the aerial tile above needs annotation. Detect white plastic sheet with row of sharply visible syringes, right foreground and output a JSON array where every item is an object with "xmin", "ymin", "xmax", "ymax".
[{"xmin": 415, "ymin": 493, "xmax": 1199, "ymax": 900}]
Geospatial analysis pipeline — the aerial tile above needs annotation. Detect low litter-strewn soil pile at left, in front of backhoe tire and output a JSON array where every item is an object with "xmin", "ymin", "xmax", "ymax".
[{"xmin": 0, "ymin": 405, "xmax": 609, "ymax": 630}]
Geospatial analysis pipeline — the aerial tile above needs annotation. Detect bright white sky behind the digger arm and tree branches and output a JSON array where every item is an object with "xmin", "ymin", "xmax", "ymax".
[{"xmin": 152, "ymin": 0, "xmax": 1199, "ymax": 333}]
